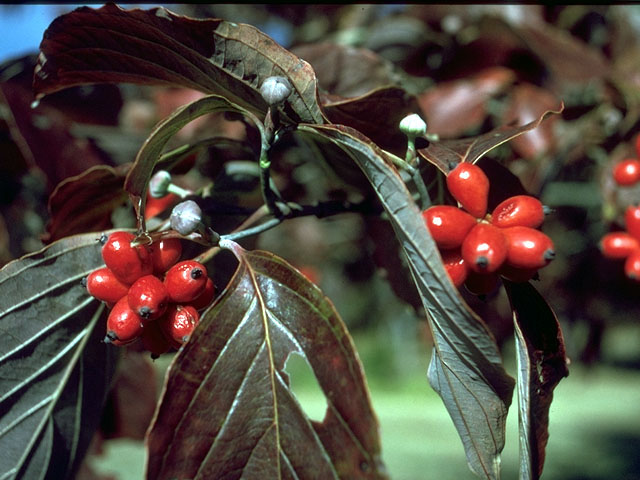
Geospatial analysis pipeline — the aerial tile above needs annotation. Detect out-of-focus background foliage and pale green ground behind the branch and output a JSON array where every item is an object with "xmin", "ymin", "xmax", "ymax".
[{"xmin": 0, "ymin": 4, "xmax": 640, "ymax": 480}]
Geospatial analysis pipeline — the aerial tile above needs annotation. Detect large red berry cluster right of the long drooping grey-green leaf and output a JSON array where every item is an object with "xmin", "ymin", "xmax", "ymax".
[{"xmin": 422, "ymin": 162, "xmax": 555, "ymax": 295}]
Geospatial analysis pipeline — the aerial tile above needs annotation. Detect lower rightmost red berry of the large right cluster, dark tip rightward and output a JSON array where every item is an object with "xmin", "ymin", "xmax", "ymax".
[{"xmin": 502, "ymin": 227, "xmax": 555, "ymax": 268}]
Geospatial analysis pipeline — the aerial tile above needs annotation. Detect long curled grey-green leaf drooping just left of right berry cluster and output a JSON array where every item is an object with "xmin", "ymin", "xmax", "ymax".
[{"xmin": 299, "ymin": 125, "xmax": 514, "ymax": 479}]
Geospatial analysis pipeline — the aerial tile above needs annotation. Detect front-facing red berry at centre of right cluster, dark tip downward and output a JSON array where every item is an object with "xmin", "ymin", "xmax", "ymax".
[{"xmin": 461, "ymin": 223, "xmax": 507, "ymax": 273}]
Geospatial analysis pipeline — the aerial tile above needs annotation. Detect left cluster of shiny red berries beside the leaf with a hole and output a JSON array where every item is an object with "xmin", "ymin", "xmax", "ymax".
[{"xmin": 85, "ymin": 232, "xmax": 215, "ymax": 357}]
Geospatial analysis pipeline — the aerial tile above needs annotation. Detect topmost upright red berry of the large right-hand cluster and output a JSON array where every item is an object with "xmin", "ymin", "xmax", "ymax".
[{"xmin": 447, "ymin": 162, "xmax": 489, "ymax": 218}]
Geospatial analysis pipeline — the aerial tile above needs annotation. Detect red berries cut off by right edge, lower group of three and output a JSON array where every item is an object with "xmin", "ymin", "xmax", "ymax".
[{"xmin": 600, "ymin": 205, "xmax": 640, "ymax": 282}]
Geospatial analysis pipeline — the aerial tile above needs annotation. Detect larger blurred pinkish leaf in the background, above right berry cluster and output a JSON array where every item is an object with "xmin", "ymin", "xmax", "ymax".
[{"xmin": 418, "ymin": 67, "xmax": 516, "ymax": 138}]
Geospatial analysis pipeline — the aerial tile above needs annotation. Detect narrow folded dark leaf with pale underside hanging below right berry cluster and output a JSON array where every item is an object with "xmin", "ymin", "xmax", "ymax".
[{"xmin": 504, "ymin": 281, "xmax": 569, "ymax": 480}]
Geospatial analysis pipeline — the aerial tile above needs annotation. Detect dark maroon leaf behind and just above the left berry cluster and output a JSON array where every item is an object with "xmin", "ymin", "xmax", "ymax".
[{"xmin": 44, "ymin": 165, "xmax": 130, "ymax": 242}]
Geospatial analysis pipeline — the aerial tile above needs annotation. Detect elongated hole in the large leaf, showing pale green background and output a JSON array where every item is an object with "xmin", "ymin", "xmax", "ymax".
[{"xmin": 284, "ymin": 352, "xmax": 328, "ymax": 422}]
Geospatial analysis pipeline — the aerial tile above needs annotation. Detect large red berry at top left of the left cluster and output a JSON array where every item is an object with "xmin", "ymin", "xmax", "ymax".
[{"xmin": 102, "ymin": 232, "xmax": 153, "ymax": 285}]
